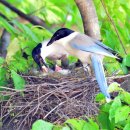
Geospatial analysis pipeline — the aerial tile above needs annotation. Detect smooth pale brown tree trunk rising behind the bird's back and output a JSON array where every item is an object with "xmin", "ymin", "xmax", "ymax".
[{"xmin": 75, "ymin": 0, "xmax": 101, "ymax": 40}]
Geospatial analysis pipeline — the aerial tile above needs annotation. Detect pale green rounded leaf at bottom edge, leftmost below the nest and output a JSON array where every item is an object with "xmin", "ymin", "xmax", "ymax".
[{"xmin": 32, "ymin": 120, "xmax": 54, "ymax": 130}]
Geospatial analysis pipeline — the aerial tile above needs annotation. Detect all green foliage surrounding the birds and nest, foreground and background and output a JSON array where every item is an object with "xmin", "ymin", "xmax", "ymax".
[{"xmin": 0, "ymin": 0, "xmax": 130, "ymax": 130}]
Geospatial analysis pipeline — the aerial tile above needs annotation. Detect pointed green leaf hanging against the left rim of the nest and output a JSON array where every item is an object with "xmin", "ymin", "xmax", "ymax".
[{"xmin": 11, "ymin": 70, "xmax": 25, "ymax": 90}]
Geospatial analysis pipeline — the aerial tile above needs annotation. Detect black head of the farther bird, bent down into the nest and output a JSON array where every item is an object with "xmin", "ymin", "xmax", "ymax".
[{"xmin": 32, "ymin": 43, "xmax": 47, "ymax": 70}]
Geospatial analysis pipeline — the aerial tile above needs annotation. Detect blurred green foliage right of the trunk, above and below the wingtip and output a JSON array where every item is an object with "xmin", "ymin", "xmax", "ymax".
[{"xmin": 94, "ymin": 0, "xmax": 130, "ymax": 74}]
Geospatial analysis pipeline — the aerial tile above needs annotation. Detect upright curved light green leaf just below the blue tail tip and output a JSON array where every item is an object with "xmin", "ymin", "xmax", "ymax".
[{"xmin": 109, "ymin": 98, "xmax": 121, "ymax": 120}]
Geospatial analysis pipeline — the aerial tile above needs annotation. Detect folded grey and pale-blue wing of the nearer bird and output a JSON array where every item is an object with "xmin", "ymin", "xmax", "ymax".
[{"xmin": 70, "ymin": 34, "xmax": 117, "ymax": 58}]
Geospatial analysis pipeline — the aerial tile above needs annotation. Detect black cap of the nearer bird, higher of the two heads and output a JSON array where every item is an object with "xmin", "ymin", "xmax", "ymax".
[{"xmin": 47, "ymin": 28, "xmax": 74, "ymax": 46}]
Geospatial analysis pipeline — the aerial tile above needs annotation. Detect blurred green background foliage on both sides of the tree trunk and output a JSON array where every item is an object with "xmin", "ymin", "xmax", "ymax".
[{"xmin": 0, "ymin": 0, "xmax": 130, "ymax": 89}]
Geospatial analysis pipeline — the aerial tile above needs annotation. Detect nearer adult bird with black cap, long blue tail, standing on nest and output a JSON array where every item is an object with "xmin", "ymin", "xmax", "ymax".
[{"xmin": 41, "ymin": 28, "xmax": 122, "ymax": 100}]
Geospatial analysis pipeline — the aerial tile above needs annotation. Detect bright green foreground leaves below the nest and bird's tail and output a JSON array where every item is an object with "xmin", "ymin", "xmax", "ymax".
[{"xmin": 32, "ymin": 83, "xmax": 130, "ymax": 130}]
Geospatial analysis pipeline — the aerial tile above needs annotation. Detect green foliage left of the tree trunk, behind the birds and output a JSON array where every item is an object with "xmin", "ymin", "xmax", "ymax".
[{"xmin": 0, "ymin": 0, "xmax": 82, "ymax": 93}]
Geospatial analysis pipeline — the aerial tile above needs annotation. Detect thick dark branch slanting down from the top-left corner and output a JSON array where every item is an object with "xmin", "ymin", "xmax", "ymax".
[{"xmin": 0, "ymin": 0, "xmax": 48, "ymax": 29}]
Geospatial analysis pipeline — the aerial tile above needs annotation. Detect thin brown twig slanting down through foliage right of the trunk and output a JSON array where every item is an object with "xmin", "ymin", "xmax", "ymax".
[{"xmin": 101, "ymin": 0, "xmax": 127, "ymax": 55}]
